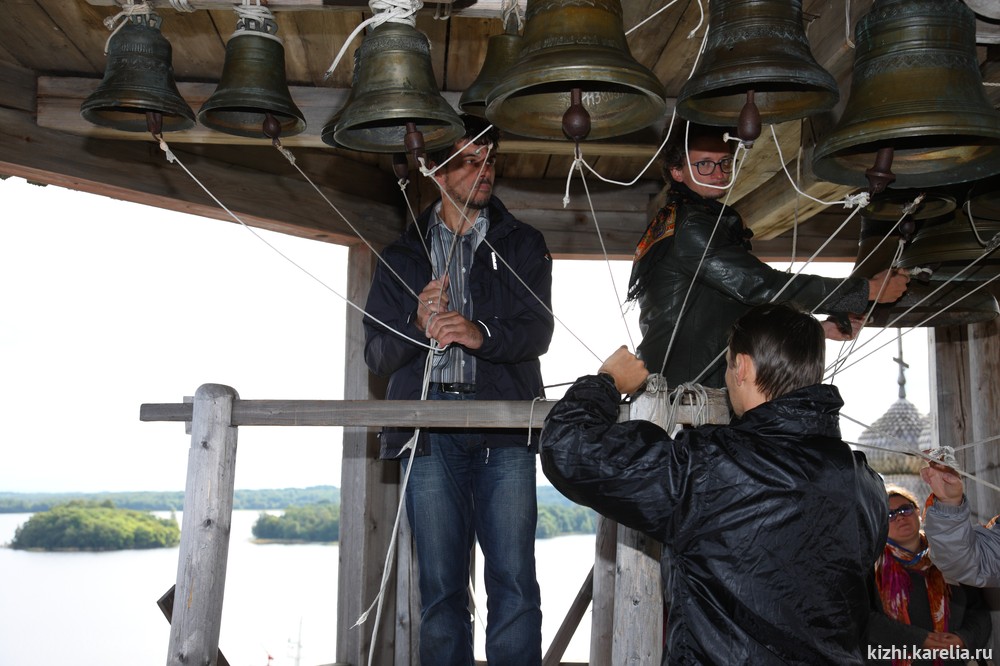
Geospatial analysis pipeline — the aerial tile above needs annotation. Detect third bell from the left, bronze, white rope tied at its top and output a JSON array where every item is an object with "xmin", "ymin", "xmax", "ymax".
[{"xmin": 322, "ymin": 22, "xmax": 465, "ymax": 153}]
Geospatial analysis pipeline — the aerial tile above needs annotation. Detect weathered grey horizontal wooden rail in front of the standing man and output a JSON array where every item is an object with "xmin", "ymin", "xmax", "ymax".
[{"xmin": 139, "ymin": 389, "xmax": 729, "ymax": 428}]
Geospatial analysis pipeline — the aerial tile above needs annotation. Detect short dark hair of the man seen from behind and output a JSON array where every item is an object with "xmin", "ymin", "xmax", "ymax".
[{"xmin": 729, "ymin": 303, "xmax": 826, "ymax": 400}]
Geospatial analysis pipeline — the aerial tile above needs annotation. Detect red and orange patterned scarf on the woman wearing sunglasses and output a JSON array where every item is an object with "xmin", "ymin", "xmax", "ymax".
[{"xmin": 875, "ymin": 532, "xmax": 951, "ymax": 666}]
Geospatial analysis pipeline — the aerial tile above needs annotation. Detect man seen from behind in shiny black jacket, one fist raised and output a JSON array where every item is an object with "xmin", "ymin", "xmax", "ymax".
[{"xmin": 541, "ymin": 305, "xmax": 889, "ymax": 666}]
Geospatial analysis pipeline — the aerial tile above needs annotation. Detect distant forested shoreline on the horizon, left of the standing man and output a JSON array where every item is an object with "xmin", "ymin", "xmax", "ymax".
[{"xmin": 0, "ymin": 486, "xmax": 340, "ymax": 513}]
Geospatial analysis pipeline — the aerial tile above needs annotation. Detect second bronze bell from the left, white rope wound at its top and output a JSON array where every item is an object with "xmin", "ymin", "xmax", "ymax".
[{"xmin": 198, "ymin": 8, "xmax": 306, "ymax": 139}]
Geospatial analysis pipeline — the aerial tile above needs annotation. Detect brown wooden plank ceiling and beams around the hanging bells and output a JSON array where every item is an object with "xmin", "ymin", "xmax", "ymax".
[{"xmin": 0, "ymin": 0, "xmax": 1000, "ymax": 260}]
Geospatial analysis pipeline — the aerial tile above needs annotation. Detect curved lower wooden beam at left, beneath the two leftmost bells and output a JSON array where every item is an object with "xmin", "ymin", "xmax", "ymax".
[{"xmin": 0, "ymin": 109, "xmax": 404, "ymax": 245}]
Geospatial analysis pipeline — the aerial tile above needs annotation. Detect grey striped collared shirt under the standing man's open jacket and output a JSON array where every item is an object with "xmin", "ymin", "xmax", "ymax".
[{"xmin": 429, "ymin": 201, "xmax": 490, "ymax": 384}]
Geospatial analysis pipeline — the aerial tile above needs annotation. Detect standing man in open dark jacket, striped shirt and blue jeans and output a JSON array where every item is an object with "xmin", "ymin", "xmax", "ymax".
[{"xmin": 364, "ymin": 116, "xmax": 553, "ymax": 666}]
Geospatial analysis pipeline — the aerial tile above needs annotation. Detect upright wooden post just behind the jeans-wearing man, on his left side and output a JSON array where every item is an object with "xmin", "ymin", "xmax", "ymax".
[{"xmin": 337, "ymin": 244, "xmax": 403, "ymax": 666}]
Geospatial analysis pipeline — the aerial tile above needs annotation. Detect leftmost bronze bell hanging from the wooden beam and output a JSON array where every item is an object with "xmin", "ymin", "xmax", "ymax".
[{"xmin": 80, "ymin": 13, "xmax": 194, "ymax": 133}]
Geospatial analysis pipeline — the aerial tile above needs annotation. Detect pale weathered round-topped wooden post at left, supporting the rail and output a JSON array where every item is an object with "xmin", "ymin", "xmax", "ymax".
[{"xmin": 167, "ymin": 384, "xmax": 239, "ymax": 666}]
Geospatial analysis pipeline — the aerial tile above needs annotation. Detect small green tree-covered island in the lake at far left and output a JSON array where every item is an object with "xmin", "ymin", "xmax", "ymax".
[{"xmin": 10, "ymin": 500, "xmax": 181, "ymax": 551}]
